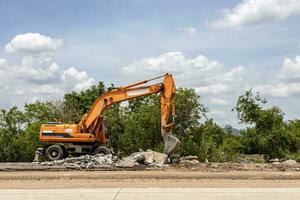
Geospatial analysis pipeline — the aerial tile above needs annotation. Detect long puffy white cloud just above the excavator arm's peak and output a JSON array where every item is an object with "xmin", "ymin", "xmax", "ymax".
[{"xmin": 121, "ymin": 51, "xmax": 244, "ymax": 94}]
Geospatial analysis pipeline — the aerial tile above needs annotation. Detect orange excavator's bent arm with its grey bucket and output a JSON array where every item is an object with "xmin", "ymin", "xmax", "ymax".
[{"xmin": 79, "ymin": 74, "xmax": 179, "ymax": 154}]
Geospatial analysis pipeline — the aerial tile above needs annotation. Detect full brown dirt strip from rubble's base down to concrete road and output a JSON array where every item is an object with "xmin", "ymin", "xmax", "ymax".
[{"xmin": 0, "ymin": 163, "xmax": 300, "ymax": 189}]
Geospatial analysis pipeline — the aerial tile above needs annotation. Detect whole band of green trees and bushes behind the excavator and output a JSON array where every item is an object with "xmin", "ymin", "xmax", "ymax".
[{"xmin": 0, "ymin": 82, "xmax": 300, "ymax": 162}]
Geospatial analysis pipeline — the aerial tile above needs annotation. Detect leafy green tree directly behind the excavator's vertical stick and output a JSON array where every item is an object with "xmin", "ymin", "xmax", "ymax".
[{"xmin": 110, "ymin": 88, "xmax": 205, "ymax": 155}]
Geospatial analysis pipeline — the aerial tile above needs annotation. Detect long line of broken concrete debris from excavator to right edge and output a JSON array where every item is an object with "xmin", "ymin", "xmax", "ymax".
[{"xmin": 36, "ymin": 153, "xmax": 300, "ymax": 171}]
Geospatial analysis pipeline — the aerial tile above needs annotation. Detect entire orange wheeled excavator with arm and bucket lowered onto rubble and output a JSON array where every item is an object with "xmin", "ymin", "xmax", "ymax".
[{"xmin": 35, "ymin": 74, "xmax": 180, "ymax": 161}]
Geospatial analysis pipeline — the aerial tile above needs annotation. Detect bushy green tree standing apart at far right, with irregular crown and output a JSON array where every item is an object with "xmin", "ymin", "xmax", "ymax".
[{"xmin": 235, "ymin": 90, "xmax": 298, "ymax": 158}]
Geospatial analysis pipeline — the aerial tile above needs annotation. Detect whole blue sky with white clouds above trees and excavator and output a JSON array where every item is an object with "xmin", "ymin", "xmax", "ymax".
[{"xmin": 0, "ymin": 0, "xmax": 300, "ymax": 127}]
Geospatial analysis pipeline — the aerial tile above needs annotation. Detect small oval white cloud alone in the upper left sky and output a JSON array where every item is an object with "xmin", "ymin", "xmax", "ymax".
[{"xmin": 4, "ymin": 33, "xmax": 63, "ymax": 54}]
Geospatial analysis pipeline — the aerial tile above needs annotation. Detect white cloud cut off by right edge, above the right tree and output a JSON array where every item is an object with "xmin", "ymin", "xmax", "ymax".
[{"xmin": 254, "ymin": 56, "xmax": 300, "ymax": 98}]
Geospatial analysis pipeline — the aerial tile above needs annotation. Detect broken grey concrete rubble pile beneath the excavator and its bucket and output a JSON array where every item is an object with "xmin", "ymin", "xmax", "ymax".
[{"xmin": 40, "ymin": 150, "xmax": 168, "ymax": 170}]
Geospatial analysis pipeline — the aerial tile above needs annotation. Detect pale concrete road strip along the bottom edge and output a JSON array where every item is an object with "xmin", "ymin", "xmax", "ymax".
[{"xmin": 0, "ymin": 188, "xmax": 300, "ymax": 200}]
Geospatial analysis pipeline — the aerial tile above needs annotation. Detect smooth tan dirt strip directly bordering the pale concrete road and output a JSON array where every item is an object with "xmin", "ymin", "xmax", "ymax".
[{"xmin": 0, "ymin": 170, "xmax": 300, "ymax": 189}]
